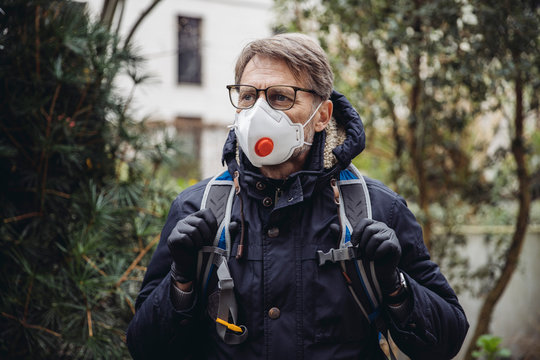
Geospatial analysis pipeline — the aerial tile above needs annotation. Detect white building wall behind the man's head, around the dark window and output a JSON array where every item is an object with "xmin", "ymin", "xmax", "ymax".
[{"xmin": 87, "ymin": 0, "xmax": 273, "ymax": 177}]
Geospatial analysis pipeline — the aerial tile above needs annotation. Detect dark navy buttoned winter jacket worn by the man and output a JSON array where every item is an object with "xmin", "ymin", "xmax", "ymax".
[{"xmin": 127, "ymin": 92, "xmax": 468, "ymax": 360}]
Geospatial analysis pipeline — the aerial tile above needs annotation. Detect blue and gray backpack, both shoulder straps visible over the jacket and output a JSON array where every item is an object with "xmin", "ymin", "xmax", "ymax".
[{"xmin": 197, "ymin": 164, "xmax": 396, "ymax": 360}]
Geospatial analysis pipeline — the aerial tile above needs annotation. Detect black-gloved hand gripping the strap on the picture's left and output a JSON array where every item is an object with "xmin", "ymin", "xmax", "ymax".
[{"xmin": 167, "ymin": 209, "xmax": 217, "ymax": 283}]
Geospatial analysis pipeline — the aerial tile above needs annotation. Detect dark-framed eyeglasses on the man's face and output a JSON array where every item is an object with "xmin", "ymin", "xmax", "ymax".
[{"xmin": 227, "ymin": 85, "xmax": 318, "ymax": 110}]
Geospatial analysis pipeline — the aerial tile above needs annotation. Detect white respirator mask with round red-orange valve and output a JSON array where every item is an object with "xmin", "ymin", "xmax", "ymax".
[{"xmin": 229, "ymin": 98, "xmax": 322, "ymax": 167}]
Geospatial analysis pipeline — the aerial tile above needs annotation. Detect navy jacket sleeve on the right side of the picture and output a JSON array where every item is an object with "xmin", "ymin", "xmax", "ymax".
[{"xmin": 374, "ymin": 188, "xmax": 469, "ymax": 360}]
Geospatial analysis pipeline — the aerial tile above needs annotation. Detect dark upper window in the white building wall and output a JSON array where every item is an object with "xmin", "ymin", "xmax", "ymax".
[{"xmin": 178, "ymin": 16, "xmax": 202, "ymax": 84}]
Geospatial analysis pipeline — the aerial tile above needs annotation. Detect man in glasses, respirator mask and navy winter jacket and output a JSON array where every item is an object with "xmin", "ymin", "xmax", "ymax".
[{"xmin": 127, "ymin": 34, "xmax": 468, "ymax": 359}]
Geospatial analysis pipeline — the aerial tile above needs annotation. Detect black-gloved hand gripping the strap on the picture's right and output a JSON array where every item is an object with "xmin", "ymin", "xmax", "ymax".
[{"xmin": 351, "ymin": 218, "xmax": 401, "ymax": 296}]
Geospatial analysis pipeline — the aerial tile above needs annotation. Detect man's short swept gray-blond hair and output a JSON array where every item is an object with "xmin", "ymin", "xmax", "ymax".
[{"xmin": 235, "ymin": 33, "xmax": 334, "ymax": 100}]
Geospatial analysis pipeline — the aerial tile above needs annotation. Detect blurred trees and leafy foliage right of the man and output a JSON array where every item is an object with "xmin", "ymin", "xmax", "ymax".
[{"xmin": 276, "ymin": 0, "xmax": 540, "ymax": 359}]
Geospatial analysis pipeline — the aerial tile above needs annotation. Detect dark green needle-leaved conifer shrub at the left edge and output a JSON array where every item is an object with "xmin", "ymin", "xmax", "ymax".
[{"xmin": 0, "ymin": 0, "xmax": 179, "ymax": 359}]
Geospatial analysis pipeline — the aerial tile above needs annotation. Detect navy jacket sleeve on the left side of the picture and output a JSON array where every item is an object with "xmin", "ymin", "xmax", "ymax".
[{"xmin": 127, "ymin": 185, "xmax": 209, "ymax": 359}]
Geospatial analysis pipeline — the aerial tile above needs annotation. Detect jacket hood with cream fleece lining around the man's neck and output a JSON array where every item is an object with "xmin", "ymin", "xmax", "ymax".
[{"xmin": 222, "ymin": 90, "xmax": 366, "ymax": 177}]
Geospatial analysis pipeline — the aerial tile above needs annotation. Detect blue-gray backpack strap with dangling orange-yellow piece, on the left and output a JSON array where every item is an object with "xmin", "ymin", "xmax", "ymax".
[{"xmin": 197, "ymin": 171, "xmax": 248, "ymax": 345}]
